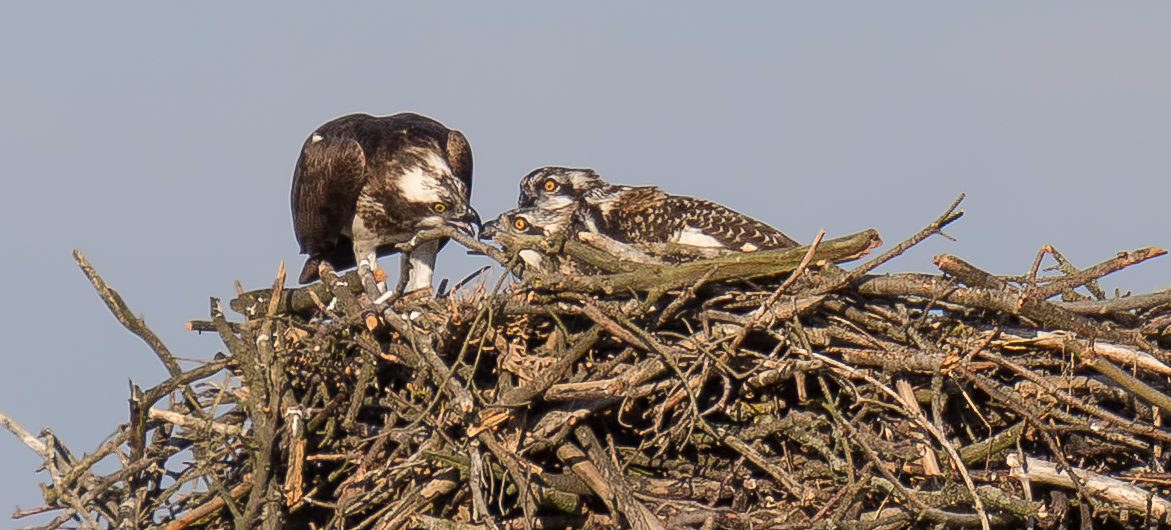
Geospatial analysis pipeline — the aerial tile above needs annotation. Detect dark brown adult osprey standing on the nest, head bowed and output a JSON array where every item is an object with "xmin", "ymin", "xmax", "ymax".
[{"xmin": 292, "ymin": 112, "xmax": 480, "ymax": 290}]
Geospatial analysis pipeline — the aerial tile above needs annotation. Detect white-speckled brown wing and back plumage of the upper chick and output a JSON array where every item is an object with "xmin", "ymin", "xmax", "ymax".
[{"xmin": 584, "ymin": 186, "xmax": 797, "ymax": 252}]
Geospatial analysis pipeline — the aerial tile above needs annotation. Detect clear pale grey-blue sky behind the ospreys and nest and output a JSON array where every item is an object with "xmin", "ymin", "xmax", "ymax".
[{"xmin": 0, "ymin": 1, "xmax": 1171, "ymax": 521}]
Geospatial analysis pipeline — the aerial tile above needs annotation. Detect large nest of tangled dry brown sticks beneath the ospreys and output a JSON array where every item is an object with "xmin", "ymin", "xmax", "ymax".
[{"xmin": 0, "ymin": 195, "xmax": 1171, "ymax": 530}]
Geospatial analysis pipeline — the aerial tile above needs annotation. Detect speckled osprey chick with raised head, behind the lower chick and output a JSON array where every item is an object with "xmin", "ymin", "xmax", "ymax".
[{"xmin": 518, "ymin": 166, "xmax": 797, "ymax": 252}]
